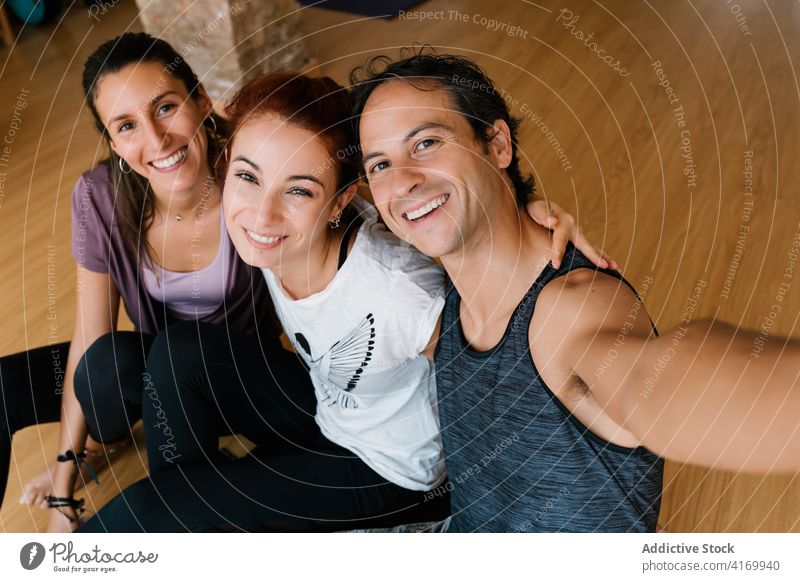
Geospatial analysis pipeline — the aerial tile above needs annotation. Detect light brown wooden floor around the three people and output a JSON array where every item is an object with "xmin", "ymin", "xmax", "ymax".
[{"xmin": 0, "ymin": 0, "xmax": 800, "ymax": 531}]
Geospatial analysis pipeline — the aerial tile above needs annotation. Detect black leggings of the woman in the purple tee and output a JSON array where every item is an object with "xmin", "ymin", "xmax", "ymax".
[{"xmin": 0, "ymin": 332, "xmax": 153, "ymax": 503}]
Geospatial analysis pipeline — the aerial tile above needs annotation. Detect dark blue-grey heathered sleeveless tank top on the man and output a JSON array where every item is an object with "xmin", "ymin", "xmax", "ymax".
[{"xmin": 435, "ymin": 245, "xmax": 664, "ymax": 532}]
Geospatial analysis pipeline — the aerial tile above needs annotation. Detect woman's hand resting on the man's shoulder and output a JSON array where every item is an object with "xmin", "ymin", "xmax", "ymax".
[{"xmin": 527, "ymin": 200, "xmax": 619, "ymax": 271}]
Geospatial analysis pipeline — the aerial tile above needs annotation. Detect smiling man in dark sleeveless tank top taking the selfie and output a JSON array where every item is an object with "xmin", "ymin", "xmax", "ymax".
[{"xmin": 351, "ymin": 53, "xmax": 800, "ymax": 531}]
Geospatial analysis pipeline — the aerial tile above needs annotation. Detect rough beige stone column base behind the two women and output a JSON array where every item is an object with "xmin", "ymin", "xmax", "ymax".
[{"xmin": 136, "ymin": 0, "xmax": 308, "ymax": 100}]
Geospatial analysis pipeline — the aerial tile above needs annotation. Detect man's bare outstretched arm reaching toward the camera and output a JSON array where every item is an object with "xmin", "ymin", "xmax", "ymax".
[{"xmin": 537, "ymin": 270, "xmax": 800, "ymax": 472}]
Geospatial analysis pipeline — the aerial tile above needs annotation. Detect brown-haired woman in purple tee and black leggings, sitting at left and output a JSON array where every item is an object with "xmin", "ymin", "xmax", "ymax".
[{"xmin": 0, "ymin": 33, "xmax": 284, "ymax": 531}]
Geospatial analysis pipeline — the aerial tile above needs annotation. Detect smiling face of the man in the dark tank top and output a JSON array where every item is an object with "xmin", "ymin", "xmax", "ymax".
[{"xmin": 360, "ymin": 80, "xmax": 507, "ymax": 257}]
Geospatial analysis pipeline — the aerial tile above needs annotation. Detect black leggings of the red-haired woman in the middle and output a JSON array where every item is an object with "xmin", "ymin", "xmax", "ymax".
[{"xmin": 79, "ymin": 323, "xmax": 449, "ymax": 532}]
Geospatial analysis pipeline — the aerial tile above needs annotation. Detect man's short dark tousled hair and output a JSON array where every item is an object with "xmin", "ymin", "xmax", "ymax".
[{"xmin": 350, "ymin": 49, "xmax": 534, "ymax": 206}]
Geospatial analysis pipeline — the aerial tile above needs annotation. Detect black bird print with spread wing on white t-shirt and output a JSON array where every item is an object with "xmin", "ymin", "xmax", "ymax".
[{"xmin": 294, "ymin": 313, "xmax": 375, "ymax": 408}]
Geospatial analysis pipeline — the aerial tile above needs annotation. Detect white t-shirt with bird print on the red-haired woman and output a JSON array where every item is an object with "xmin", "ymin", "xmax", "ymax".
[{"xmin": 263, "ymin": 199, "xmax": 445, "ymax": 491}]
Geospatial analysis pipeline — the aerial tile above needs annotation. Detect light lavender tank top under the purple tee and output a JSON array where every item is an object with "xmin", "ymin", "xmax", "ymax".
[{"xmin": 142, "ymin": 208, "xmax": 227, "ymax": 319}]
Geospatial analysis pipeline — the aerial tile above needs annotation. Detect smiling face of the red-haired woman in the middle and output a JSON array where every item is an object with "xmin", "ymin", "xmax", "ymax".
[{"xmin": 222, "ymin": 115, "xmax": 343, "ymax": 277}]
